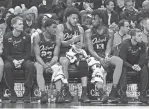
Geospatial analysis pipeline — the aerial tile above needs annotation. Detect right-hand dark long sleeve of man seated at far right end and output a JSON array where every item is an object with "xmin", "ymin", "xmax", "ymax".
[{"xmin": 139, "ymin": 44, "xmax": 147, "ymax": 67}]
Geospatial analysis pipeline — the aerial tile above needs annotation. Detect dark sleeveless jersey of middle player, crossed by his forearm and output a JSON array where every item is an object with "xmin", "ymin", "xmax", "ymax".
[{"xmin": 60, "ymin": 24, "xmax": 80, "ymax": 55}]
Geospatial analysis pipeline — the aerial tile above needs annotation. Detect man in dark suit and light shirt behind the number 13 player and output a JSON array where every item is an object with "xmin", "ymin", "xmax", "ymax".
[{"xmin": 103, "ymin": 0, "xmax": 119, "ymax": 27}]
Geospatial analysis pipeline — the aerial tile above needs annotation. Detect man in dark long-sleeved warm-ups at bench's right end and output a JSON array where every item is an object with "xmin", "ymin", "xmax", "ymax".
[{"xmin": 119, "ymin": 29, "xmax": 148, "ymax": 103}]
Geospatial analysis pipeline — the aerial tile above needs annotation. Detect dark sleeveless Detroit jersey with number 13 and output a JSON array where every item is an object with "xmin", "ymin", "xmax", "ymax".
[{"xmin": 91, "ymin": 28, "xmax": 109, "ymax": 57}]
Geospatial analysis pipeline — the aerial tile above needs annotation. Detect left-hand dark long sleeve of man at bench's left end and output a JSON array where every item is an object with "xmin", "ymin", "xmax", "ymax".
[{"xmin": 3, "ymin": 37, "xmax": 14, "ymax": 62}]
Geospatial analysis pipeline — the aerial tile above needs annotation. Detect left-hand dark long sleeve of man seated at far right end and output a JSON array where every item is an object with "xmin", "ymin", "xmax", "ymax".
[{"xmin": 119, "ymin": 43, "xmax": 132, "ymax": 68}]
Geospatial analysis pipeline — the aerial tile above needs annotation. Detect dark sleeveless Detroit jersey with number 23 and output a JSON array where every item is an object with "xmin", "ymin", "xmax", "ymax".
[{"xmin": 39, "ymin": 34, "xmax": 56, "ymax": 63}]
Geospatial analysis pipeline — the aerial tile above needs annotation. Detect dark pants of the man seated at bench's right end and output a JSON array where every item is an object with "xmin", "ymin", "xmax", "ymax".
[{"xmin": 119, "ymin": 66, "xmax": 148, "ymax": 95}]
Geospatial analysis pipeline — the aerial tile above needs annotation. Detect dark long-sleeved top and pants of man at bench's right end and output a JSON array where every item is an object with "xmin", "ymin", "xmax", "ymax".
[{"xmin": 120, "ymin": 39, "xmax": 148, "ymax": 101}]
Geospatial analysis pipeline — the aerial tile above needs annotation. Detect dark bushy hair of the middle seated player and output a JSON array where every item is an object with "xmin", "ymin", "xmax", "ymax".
[{"xmin": 64, "ymin": 7, "xmax": 80, "ymax": 18}]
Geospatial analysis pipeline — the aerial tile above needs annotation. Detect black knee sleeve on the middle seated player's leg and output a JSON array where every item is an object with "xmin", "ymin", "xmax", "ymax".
[{"xmin": 79, "ymin": 60, "xmax": 89, "ymax": 78}]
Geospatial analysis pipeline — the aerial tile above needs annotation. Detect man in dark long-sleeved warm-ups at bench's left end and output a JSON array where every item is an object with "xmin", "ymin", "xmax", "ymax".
[{"xmin": 3, "ymin": 16, "xmax": 35, "ymax": 103}]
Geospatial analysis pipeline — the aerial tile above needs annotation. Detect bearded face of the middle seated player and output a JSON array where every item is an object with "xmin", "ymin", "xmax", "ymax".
[{"xmin": 68, "ymin": 14, "xmax": 79, "ymax": 26}]
